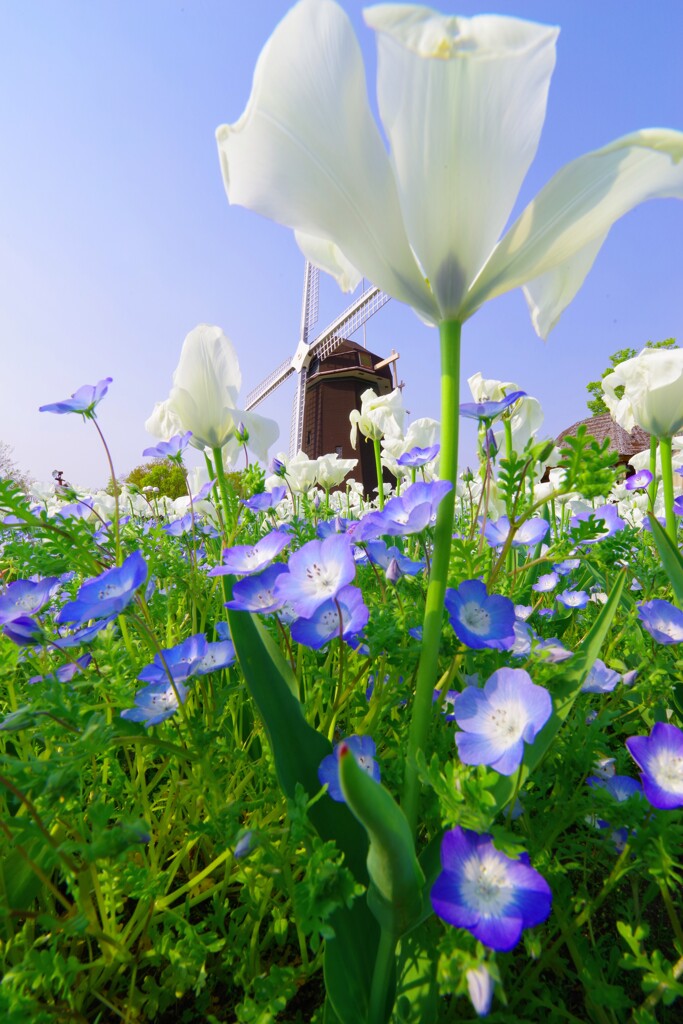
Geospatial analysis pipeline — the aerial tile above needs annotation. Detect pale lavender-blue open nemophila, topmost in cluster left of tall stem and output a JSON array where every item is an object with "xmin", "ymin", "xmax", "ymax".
[{"xmin": 274, "ymin": 534, "xmax": 355, "ymax": 618}]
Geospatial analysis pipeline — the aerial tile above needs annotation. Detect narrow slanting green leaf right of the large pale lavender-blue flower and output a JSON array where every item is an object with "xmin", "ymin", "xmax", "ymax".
[{"xmin": 492, "ymin": 571, "xmax": 626, "ymax": 813}]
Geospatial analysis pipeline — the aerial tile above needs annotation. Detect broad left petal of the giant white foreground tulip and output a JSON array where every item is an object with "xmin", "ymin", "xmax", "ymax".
[{"xmin": 216, "ymin": 0, "xmax": 438, "ymax": 319}]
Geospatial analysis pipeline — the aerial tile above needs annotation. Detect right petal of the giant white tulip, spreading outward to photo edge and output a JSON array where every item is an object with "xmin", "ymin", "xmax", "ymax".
[{"xmin": 463, "ymin": 128, "xmax": 683, "ymax": 330}]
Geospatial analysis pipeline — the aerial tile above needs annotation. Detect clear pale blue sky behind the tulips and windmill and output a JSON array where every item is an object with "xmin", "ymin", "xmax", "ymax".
[{"xmin": 0, "ymin": 0, "xmax": 683, "ymax": 486}]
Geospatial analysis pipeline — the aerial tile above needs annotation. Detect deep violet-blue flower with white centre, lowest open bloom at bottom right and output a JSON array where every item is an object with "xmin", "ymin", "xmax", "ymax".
[{"xmin": 431, "ymin": 825, "xmax": 552, "ymax": 952}]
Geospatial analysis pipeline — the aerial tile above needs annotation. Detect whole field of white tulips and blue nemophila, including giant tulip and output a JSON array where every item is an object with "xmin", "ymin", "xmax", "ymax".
[{"xmin": 0, "ymin": 0, "xmax": 683, "ymax": 1024}]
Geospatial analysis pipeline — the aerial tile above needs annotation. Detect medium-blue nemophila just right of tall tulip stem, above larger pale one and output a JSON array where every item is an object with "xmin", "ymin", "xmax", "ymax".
[{"xmin": 445, "ymin": 580, "xmax": 515, "ymax": 650}]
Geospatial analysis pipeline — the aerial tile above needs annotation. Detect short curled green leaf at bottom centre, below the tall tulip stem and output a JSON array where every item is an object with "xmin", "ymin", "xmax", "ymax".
[{"xmin": 339, "ymin": 744, "xmax": 425, "ymax": 939}]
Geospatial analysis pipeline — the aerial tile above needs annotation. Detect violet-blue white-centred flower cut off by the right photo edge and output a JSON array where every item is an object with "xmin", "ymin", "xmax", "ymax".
[{"xmin": 626, "ymin": 722, "xmax": 683, "ymax": 811}]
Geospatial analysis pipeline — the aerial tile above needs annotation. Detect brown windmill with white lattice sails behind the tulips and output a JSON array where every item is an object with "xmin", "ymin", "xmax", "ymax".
[{"xmin": 246, "ymin": 262, "xmax": 398, "ymax": 492}]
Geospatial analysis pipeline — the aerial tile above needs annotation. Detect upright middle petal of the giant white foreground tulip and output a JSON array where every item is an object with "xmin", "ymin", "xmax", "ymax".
[{"xmin": 365, "ymin": 4, "xmax": 558, "ymax": 317}]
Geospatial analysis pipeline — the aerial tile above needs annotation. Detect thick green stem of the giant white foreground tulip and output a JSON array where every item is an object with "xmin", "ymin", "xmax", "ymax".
[{"xmin": 402, "ymin": 321, "xmax": 462, "ymax": 833}]
